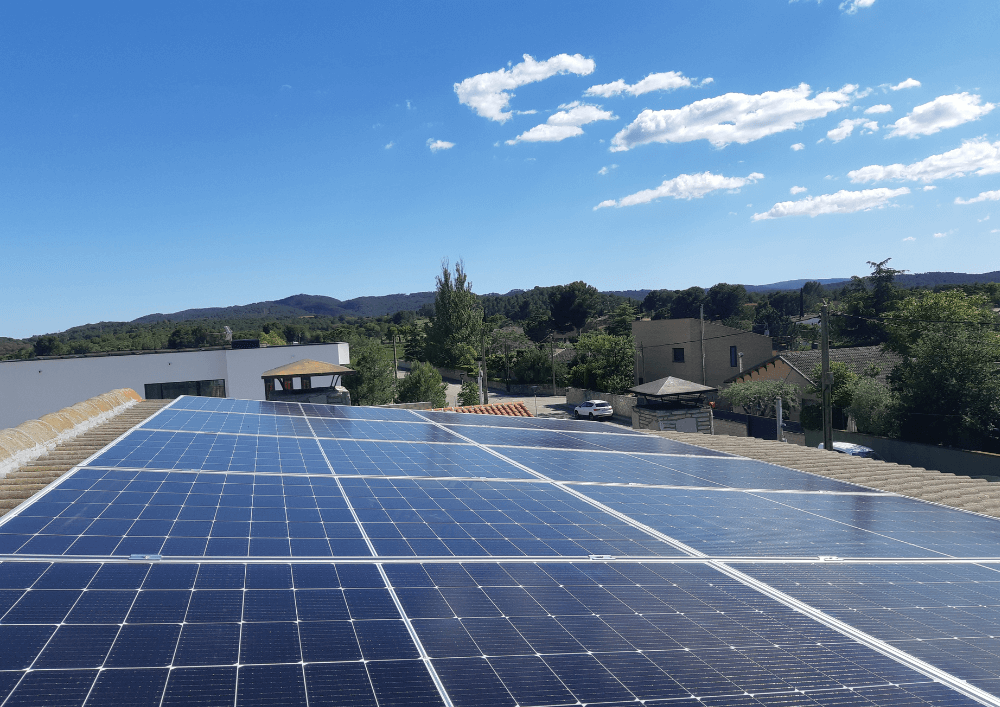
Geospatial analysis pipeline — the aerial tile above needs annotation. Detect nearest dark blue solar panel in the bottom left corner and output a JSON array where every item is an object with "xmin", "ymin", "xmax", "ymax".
[{"xmin": 0, "ymin": 562, "xmax": 441, "ymax": 705}]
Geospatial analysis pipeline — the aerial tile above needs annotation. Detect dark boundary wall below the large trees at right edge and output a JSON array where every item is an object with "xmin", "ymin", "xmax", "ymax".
[{"xmin": 806, "ymin": 430, "xmax": 1000, "ymax": 476}]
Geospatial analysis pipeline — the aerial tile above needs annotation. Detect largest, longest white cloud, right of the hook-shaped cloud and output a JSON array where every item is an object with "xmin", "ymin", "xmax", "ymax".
[{"xmin": 611, "ymin": 84, "xmax": 858, "ymax": 152}]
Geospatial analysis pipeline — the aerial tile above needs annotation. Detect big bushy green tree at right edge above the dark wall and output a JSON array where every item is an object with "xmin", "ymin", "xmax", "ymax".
[{"xmin": 889, "ymin": 325, "xmax": 1000, "ymax": 449}]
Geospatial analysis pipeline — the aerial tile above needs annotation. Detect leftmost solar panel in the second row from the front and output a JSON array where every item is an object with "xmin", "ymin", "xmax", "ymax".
[{"xmin": 0, "ymin": 469, "xmax": 371, "ymax": 557}]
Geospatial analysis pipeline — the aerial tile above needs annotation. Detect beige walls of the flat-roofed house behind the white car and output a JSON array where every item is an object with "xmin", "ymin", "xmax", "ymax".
[{"xmin": 632, "ymin": 319, "xmax": 774, "ymax": 387}]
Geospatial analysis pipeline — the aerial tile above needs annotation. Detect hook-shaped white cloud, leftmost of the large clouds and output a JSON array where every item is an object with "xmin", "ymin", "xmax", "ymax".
[{"xmin": 455, "ymin": 54, "xmax": 597, "ymax": 123}]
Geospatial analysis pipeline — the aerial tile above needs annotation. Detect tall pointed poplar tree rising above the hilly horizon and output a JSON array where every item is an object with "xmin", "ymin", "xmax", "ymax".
[{"xmin": 426, "ymin": 260, "xmax": 483, "ymax": 368}]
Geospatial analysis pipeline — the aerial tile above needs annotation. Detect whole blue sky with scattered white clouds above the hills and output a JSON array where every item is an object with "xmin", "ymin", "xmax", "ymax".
[{"xmin": 0, "ymin": 0, "xmax": 1000, "ymax": 337}]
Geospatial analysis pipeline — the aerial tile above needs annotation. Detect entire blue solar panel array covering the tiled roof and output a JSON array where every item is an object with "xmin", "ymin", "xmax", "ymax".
[{"xmin": 0, "ymin": 398, "xmax": 1000, "ymax": 707}]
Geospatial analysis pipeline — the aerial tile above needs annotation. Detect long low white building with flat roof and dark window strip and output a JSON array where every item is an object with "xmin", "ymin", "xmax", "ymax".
[{"xmin": 0, "ymin": 342, "xmax": 351, "ymax": 429}]
